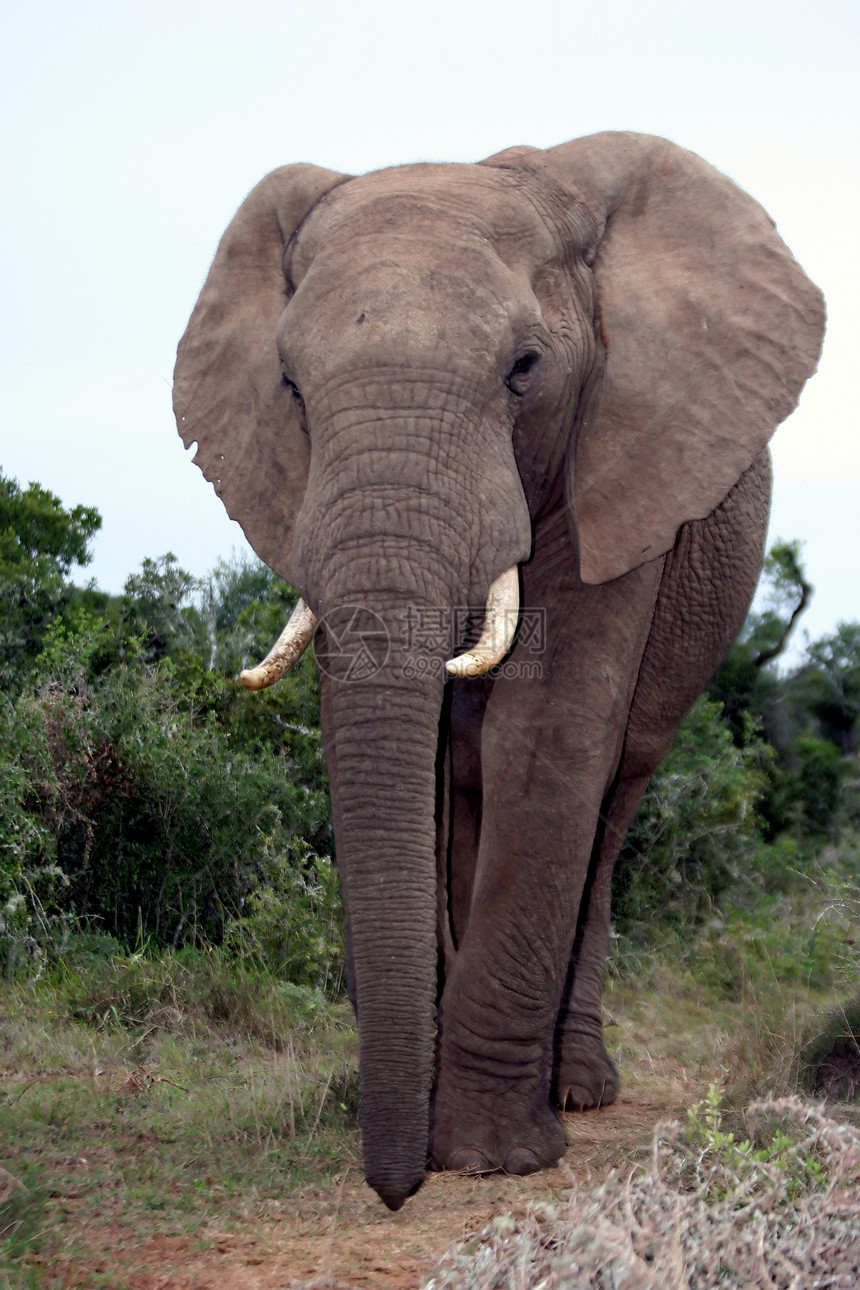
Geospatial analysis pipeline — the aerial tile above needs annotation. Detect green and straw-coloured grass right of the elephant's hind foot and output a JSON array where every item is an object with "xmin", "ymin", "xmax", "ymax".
[{"xmin": 603, "ymin": 844, "xmax": 860, "ymax": 1100}]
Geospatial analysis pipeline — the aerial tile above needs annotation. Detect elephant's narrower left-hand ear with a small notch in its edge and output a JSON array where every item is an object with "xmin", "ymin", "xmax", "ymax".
[{"xmin": 173, "ymin": 165, "xmax": 348, "ymax": 581}]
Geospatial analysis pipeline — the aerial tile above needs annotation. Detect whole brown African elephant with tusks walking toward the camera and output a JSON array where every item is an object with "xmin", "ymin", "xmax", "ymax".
[{"xmin": 174, "ymin": 133, "xmax": 824, "ymax": 1209}]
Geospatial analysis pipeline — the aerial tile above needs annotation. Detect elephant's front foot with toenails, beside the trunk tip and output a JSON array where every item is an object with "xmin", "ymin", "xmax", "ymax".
[{"xmin": 431, "ymin": 1106, "xmax": 565, "ymax": 1174}]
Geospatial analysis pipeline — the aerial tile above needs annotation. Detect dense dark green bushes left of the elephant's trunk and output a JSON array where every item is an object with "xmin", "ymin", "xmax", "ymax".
[{"xmin": 0, "ymin": 536, "xmax": 342, "ymax": 989}]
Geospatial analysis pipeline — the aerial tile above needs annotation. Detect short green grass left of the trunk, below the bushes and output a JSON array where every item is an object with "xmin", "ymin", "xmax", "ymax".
[{"xmin": 0, "ymin": 947, "xmax": 360, "ymax": 1287}]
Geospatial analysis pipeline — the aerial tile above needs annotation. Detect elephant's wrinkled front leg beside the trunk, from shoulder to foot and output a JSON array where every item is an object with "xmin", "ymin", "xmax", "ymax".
[{"xmin": 431, "ymin": 534, "xmax": 663, "ymax": 1173}]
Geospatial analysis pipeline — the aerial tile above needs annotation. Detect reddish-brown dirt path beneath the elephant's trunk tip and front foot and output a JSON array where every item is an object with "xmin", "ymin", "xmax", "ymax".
[{"xmin": 55, "ymin": 1081, "xmax": 696, "ymax": 1290}]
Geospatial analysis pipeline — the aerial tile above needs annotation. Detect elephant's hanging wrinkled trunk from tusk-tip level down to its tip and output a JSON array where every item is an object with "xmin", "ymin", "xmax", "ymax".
[{"xmin": 326, "ymin": 645, "xmax": 442, "ymax": 1209}]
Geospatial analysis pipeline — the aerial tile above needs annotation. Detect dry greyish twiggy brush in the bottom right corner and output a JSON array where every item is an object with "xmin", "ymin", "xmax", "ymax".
[{"xmin": 423, "ymin": 1098, "xmax": 860, "ymax": 1290}]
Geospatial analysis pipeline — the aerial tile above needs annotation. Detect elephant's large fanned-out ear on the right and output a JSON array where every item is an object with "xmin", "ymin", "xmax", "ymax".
[{"xmin": 538, "ymin": 133, "xmax": 824, "ymax": 583}]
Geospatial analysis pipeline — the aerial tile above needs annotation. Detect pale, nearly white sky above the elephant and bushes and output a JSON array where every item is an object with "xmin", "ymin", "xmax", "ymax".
[{"xmin": 0, "ymin": 0, "xmax": 860, "ymax": 660}]
